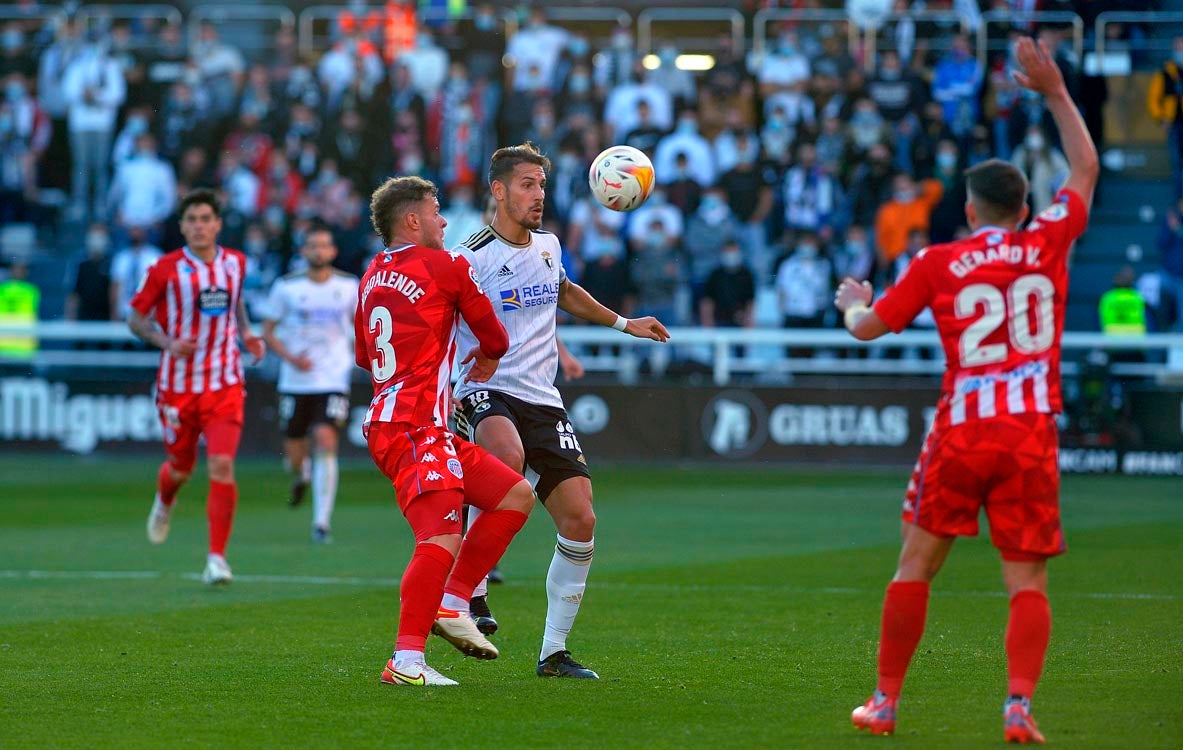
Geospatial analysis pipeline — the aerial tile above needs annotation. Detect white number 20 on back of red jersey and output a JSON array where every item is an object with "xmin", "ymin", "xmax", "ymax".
[{"xmin": 953, "ymin": 273, "xmax": 1055, "ymax": 367}]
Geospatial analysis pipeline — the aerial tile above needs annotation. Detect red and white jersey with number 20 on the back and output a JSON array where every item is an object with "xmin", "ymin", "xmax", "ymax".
[{"xmin": 874, "ymin": 190, "xmax": 1088, "ymax": 427}]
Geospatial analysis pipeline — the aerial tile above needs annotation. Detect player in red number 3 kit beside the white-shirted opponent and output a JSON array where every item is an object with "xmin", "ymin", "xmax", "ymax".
[{"xmin": 354, "ymin": 177, "xmax": 534, "ymax": 686}]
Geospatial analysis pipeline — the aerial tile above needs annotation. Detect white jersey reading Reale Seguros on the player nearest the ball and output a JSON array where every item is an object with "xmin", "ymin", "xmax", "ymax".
[{"xmin": 454, "ymin": 226, "xmax": 567, "ymax": 408}]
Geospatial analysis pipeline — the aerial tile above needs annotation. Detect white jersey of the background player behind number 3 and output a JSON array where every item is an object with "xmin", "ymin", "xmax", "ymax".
[{"xmin": 267, "ymin": 270, "xmax": 357, "ymax": 394}]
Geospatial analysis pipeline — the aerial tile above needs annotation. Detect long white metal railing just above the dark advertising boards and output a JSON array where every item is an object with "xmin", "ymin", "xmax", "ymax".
[{"xmin": 0, "ymin": 321, "xmax": 1183, "ymax": 384}]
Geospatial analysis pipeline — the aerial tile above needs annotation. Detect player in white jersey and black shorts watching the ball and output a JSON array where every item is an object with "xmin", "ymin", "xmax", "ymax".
[{"xmin": 441, "ymin": 143, "xmax": 670, "ymax": 679}]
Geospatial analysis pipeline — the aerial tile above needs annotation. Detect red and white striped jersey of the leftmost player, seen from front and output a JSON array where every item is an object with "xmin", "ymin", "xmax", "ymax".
[{"xmin": 131, "ymin": 246, "xmax": 246, "ymax": 393}]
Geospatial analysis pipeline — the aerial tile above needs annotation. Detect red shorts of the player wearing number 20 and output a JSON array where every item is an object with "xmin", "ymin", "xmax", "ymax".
[{"xmin": 903, "ymin": 413, "xmax": 1067, "ymax": 562}]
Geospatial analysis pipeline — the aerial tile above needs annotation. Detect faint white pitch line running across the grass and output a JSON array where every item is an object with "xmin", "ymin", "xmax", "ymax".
[{"xmin": 0, "ymin": 570, "xmax": 1183, "ymax": 601}]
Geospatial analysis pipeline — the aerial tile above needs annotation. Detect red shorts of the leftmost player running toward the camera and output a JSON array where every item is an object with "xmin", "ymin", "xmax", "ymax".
[{"xmin": 156, "ymin": 383, "xmax": 246, "ymax": 472}]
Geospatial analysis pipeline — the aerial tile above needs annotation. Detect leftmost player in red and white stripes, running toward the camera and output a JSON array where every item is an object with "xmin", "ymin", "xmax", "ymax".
[{"xmin": 128, "ymin": 189, "xmax": 266, "ymax": 583}]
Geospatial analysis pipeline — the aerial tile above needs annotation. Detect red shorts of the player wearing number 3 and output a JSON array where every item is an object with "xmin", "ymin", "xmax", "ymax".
[{"xmin": 367, "ymin": 422, "xmax": 524, "ymax": 542}]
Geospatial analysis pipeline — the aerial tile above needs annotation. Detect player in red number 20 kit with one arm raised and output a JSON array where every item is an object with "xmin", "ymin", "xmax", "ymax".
[{"xmin": 835, "ymin": 39, "xmax": 1098, "ymax": 743}]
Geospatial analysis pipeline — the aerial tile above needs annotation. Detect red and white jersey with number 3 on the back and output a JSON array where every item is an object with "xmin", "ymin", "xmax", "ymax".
[{"xmin": 354, "ymin": 245, "xmax": 510, "ymax": 428}]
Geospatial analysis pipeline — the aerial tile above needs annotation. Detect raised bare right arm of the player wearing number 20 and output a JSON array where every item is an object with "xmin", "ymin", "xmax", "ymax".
[{"xmin": 1015, "ymin": 37, "xmax": 1100, "ymax": 206}]
